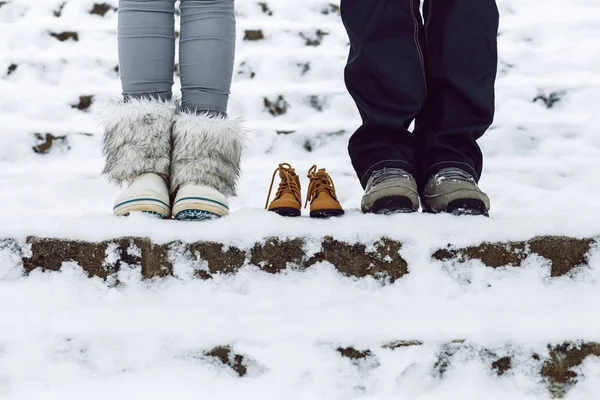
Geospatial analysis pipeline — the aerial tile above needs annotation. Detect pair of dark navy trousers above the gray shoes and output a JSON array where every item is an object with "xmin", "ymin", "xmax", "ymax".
[{"xmin": 341, "ymin": 0, "xmax": 498, "ymax": 187}]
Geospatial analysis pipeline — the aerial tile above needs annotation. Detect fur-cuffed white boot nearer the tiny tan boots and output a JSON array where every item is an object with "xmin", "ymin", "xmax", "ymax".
[{"xmin": 171, "ymin": 112, "xmax": 246, "ymax": 220}]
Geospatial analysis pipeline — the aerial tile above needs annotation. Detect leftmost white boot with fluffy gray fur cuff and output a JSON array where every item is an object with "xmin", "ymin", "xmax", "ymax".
[{"xmin": 103, "ymin": 99, "xmax": 177, "ymax": 218}]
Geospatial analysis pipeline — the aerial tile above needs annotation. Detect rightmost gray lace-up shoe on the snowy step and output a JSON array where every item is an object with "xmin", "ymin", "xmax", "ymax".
[{"xmin": 422, "ymin": 168, "xmax": 490, "ymax": 216}]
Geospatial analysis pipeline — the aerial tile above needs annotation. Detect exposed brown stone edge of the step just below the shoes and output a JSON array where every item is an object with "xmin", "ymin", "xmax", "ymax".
[{"xmin": 0, "ymin": 236, "xmax": 597, "ymax": 283}]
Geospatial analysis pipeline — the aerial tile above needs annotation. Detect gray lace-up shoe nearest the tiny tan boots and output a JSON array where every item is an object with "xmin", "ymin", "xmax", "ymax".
[{"xmin": 361, "ymin": 168, "xmax": 419, "ymax": 214}]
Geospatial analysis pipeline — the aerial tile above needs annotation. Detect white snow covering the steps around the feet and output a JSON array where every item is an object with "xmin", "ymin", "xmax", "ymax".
[{"xmin": 0, "ymin": 0, "xmax": 600, "ymax": 400}]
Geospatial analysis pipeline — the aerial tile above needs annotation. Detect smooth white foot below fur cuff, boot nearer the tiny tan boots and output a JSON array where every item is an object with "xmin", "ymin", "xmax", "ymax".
[{"xmin": 173, "ymin": 184, "xmax": 229, "ymax": 220}]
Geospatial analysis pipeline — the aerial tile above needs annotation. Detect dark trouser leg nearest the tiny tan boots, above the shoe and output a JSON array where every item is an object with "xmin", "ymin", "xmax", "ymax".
[{"xmin": 341, "ymin": 0, "xmax": 426, "ymax": 187}]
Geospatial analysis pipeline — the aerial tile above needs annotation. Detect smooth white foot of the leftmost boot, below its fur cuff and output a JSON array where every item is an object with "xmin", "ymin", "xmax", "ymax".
[{"xmin": 113, "ymin": 173, "xmax": 171, "ymax": 218}]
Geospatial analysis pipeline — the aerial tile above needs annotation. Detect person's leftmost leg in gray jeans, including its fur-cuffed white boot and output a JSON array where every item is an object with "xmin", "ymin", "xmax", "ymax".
[{"xmin": 104, "ymin": 0, "xmax": 176, "ymax": 217}]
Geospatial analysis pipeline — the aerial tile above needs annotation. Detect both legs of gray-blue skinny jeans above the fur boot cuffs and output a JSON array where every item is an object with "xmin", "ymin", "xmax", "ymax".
[{"xmin": 118, "ymin": 0, "xmax": 235, "ymax": 114}]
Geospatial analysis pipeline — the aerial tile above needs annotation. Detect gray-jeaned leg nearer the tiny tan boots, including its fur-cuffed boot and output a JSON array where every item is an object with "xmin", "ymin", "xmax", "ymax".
[{"xmin": 171, "ymin": 0, "xmax": 245, "ymax": 219}]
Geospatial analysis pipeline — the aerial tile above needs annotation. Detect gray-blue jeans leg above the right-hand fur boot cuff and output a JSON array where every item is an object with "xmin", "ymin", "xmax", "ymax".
[{"xmin": 179, "ymin": 0, "xmax": 235, "ymax": 114}]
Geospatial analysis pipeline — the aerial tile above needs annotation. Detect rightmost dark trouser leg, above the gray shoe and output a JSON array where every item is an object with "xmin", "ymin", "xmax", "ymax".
[{"xmin": 415, "ymin": 0, "xmax": 498, "ymax": 181}]
